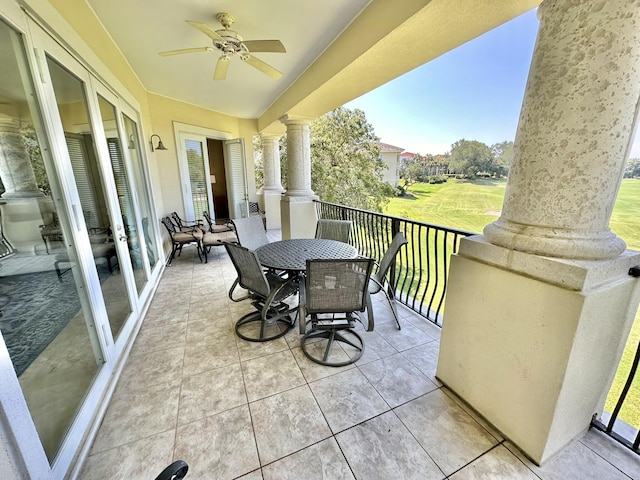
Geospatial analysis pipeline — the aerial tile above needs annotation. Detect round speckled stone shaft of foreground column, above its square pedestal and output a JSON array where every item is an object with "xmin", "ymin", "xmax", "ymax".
[{"xmin": 484, "ymin": 0, "xmax": 640, "ymax": 259}]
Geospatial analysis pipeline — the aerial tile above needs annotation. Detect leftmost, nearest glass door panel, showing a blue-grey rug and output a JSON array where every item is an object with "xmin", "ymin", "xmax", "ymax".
[{"xmin": 0, "ymin": 20, "xmax": 105, "ymax": 462}]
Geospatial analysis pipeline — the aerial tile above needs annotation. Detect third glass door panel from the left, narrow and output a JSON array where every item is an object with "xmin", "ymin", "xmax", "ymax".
[{"xmin": 98, "ymin": 95, "xmax": 148, "ymax": 294}]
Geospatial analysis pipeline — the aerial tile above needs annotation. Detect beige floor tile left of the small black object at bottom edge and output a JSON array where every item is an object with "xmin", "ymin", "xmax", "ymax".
[{"xmin": 79, "ymin": 429, "xmax": 175, "ymax": 480}]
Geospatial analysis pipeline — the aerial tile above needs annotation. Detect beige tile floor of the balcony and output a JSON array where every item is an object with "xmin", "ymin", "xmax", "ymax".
[{"xmin": 80, "ymin": 244, "xmax": 640, "ymax": 480}]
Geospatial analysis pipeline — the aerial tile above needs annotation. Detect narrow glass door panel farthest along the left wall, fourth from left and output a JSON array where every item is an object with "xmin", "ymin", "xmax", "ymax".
[{"xmin": 122, "ymin": 113, "xmax": 159, "ymax": 270}]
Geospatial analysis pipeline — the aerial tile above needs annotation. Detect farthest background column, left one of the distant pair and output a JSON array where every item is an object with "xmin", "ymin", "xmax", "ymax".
[{"xmin": 260, "ymin": 133, "xmax": 284, "ymax": 230}]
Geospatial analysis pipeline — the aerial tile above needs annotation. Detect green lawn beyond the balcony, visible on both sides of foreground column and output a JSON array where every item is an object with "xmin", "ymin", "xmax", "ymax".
[{"xmin": 384, "ymin": 179, "xmax": 640, "ymax": 428}]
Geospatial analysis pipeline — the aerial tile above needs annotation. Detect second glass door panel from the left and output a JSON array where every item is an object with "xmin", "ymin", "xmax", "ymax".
[{"xmin": 47, "ymin": 57, "xmax": 132, "ymax": 339}]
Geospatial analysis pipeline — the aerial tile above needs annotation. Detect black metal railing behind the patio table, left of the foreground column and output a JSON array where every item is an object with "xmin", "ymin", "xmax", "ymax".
[{"xmin": 316, "ymin": 201, "xmax": 475, "ymax": 326}]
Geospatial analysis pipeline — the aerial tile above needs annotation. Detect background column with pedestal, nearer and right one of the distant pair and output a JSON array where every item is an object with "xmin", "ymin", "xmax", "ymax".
[{"xmin": 280, "ymin": 115, "xmax": 317, "ymax": 238}]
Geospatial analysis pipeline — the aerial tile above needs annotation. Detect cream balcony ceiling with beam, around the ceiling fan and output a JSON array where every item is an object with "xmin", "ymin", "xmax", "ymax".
[{"xmin": 82, "ymin": 0, "xmax": 539, "ymax": 129}]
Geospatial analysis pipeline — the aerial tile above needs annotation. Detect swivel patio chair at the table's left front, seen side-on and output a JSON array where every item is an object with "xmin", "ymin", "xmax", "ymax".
[{"xmin": 224, "ymin": 244, "xmax": 299, "ymax": 342}]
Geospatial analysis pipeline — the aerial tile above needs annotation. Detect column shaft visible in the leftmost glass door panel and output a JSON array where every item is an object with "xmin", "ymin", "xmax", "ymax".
[{"xmin": 0, "ymin": 116, "xmax": 44, "ymax": 200}]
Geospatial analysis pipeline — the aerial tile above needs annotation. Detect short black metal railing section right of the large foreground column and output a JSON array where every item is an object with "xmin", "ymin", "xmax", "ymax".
[{"xmin": 591, "ymin": 266, "xmax": 640, "ymax": 455}]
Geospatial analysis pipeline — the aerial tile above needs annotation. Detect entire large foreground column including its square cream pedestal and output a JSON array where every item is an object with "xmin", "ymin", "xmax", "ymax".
[{"xmin": 437, "ymin": 0, "xmax": 640, "ymax": 463}]
